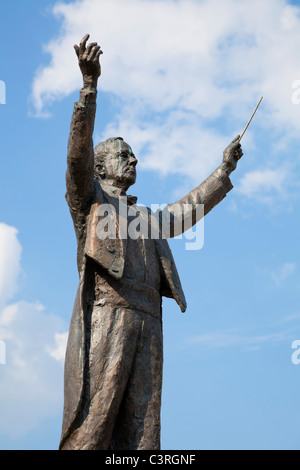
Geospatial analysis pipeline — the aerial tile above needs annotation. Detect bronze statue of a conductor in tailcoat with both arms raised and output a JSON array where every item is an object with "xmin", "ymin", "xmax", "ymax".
[{"xmin": 60, "ymin": 35, "xmax": 243, "ymax": 450}]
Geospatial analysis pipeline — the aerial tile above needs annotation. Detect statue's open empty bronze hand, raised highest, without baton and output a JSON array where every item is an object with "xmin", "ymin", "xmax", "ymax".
[{"xmin": 74, "ymin": 34, "xmax": 103, "ymax": 87}]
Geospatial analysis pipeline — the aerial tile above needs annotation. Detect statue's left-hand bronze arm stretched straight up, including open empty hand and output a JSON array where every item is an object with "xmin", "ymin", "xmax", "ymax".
[{"xmin": 66, "ymin": 34, "xmax": 102, "ymax": 215}]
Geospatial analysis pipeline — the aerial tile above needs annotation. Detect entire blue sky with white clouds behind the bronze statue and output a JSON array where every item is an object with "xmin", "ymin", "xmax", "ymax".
[{"xmin": 0, "ymin": 0, "xmax": 300, "ymax": 450}]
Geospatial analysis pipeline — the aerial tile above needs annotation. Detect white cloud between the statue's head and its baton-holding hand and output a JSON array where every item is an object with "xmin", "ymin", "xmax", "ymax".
[{"xmin": 103, "ymin": 112, "xmax": 229, "ymax": 185}]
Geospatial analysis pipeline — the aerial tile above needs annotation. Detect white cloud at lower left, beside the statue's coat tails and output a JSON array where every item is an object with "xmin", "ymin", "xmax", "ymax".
[{"xmin": 0, "ymin": 301, "xmax": 65, "ymax": 438}]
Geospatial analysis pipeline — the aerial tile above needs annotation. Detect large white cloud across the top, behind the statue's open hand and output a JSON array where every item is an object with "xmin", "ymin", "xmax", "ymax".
[{"xmin": 33, "ymin": 0, "xmax": 300, "ymax": 123}]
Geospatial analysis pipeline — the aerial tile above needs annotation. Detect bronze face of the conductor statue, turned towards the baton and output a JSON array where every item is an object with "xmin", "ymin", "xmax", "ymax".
[{"xmin": 103, "ymin": 140, "xmax": 138, "ymax": 189}]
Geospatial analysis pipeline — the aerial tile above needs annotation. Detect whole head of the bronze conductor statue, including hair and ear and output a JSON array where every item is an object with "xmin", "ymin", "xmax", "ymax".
[{"xmin": 94, "ymin": 137, "xmax": 138, "ymax": 191}]
